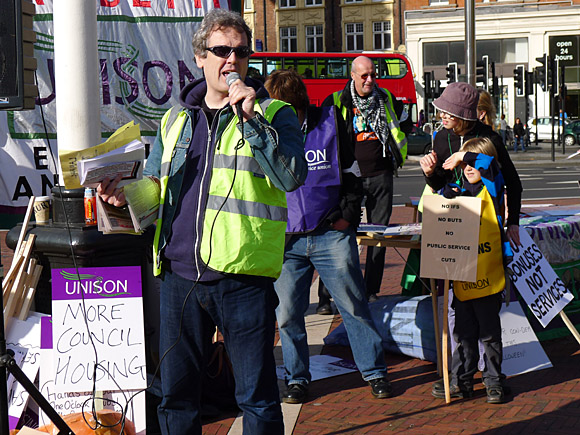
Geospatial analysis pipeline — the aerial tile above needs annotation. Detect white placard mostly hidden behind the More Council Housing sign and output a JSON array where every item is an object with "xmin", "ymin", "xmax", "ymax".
[{"xmin": 38, "ymin": 317, "xmax": 147, "ymax": 435}]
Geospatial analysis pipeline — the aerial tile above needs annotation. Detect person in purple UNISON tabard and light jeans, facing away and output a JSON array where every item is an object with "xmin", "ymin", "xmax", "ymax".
[{"xmin": 264, "ymin": 70, "xmax": 392, "ymax": 403}]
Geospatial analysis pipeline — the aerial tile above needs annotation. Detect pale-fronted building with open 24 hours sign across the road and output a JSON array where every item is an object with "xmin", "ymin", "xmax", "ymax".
[{"xmin": 404, "ymin": 0, "xmax": 580, "ymax": 125}]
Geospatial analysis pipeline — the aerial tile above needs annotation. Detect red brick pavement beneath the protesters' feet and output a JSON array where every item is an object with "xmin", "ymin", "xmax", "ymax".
[{"xmin": 203, "ymin": 203, "xmax": 580, "ymax": 435}]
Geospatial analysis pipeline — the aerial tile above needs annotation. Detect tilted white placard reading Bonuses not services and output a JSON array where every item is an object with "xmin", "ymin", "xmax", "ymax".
[{"xmin": 507, "ymin": 232, "xmax": 574, "ymax": 328}]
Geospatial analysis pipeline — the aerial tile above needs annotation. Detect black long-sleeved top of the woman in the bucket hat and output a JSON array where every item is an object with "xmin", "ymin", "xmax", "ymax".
[{"xmin": 425, "ymin": 121, "xmax": 522, "ymax": 225}]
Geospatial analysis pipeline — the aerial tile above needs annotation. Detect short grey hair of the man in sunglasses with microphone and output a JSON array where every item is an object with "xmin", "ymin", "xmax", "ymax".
[{"xmin": 192, "ymin": 9, "xmax": 252, "ymax": 57}]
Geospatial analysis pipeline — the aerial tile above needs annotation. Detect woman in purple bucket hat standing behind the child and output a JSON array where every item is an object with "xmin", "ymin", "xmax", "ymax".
[{"xmin": 420, "ymin": 82, "xmax": 522, "ymax": 245}]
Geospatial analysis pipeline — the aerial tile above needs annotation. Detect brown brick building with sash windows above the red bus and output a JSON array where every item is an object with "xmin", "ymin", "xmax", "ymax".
[{"xmin": 244, "ymin": 0, "xmax": 402, "ymax": 52}]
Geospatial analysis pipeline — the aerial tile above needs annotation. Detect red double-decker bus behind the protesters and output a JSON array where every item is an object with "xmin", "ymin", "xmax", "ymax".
[{"xmin": 248, "ymin": 52, "xmax": 417, "ymax": 110}]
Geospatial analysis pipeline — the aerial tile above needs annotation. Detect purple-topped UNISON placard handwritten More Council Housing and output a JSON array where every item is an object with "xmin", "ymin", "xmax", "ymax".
[{"xmin": 52, "ymin": 266, "xmax": 147, "ymax": 392}]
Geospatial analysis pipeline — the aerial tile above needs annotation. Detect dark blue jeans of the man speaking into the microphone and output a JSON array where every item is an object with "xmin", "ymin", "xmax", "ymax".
[{"xmin": 157, "ymin": 272, "xmax": 284, "ymax": 435}]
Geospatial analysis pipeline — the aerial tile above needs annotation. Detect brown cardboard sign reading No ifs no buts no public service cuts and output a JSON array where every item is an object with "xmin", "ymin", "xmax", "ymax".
[{"xmin": 421, "ymin": 195, "xmax": 481, "ymax": 282}]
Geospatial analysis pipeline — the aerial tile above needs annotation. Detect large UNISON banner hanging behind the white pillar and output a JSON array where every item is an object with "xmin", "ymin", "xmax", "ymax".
[{"xmin": 0, "ymin": 0, "xmax": 229, "ymax": 228}]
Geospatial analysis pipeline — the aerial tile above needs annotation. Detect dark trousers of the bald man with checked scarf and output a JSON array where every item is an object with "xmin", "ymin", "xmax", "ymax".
[{"xmin": 362, "ymin": 171, "xmax": 393, "ymax": 296}]
